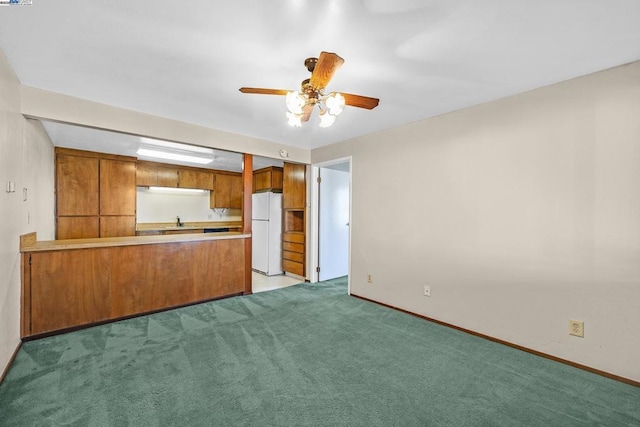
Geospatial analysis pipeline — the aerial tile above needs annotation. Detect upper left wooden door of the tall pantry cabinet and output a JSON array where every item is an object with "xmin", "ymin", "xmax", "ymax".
[{"xmin": 56, "ymin": 154, "xmax": 100, "ymax": 216}]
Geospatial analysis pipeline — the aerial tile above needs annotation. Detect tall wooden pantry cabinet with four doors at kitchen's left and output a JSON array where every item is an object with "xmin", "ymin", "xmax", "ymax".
[{"xmin": 56, "ymin": 148, "xmax": 136, "ymax": 239}]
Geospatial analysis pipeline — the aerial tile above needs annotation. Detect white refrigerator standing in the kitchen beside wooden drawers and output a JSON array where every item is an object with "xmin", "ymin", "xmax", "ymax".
[{"xmin": 251, "ymin": 192, "xmax": 282, "ymax": 276}]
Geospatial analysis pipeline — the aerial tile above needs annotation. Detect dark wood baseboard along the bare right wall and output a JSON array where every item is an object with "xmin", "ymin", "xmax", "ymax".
[{"xmin": 351, "ymin": 293, "xmax": 640, "ymax": 387}]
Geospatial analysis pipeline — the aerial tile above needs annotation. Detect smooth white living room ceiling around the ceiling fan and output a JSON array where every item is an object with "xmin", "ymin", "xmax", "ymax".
[{"xmin": 0, "ymin": 0, "xmax": 640, "ymax": 155}]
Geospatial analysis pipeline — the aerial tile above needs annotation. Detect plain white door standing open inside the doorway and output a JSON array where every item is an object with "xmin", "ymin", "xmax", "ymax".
[{"xmin": 318, "ymin": 169, "xmax": 350, "ymax": 280}]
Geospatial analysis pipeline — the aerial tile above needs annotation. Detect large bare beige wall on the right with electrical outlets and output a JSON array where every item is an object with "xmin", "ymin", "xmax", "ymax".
[{"xmin": 311, "ymin": 62, "xmax": 640, "ymax": 381}]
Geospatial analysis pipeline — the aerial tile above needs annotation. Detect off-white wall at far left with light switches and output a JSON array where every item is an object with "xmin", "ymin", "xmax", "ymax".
[{"xmin": 0, "ymin": 50, "xmax": 54, "ymax": 372}]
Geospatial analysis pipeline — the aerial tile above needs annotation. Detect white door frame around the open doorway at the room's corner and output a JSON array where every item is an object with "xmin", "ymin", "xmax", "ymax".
[{"xmin": 307, "ymin": 156, "xmax": 353, "ymax": 293}]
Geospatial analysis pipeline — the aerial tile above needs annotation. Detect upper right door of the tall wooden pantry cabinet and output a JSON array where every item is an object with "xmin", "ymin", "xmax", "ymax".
[{"xmin": 100, "ymin": 159, "xmax": 136, "ymax": 215}]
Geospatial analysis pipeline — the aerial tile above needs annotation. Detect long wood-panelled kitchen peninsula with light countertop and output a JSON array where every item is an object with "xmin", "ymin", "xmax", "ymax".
[{"xmin": 20, "ymin": 232, "xmax": 251, "ymax": 338}]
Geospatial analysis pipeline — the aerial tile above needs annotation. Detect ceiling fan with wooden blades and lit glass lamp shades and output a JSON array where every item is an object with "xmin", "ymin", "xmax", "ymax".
[{"xmin": 240, "ymin": 52, "xmax": 380, "ymax": 127}]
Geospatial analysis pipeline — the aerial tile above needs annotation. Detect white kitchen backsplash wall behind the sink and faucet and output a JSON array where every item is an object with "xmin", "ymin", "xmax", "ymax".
[{"xmin": 136, "ymin": 187, "xmax": 242, "ymax": 223}]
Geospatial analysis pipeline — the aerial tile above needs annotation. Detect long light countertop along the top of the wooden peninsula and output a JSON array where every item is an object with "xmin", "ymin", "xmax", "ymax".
[{"xmin": 20, "ymin": 232, "xmax": 251, "ymax": 253}]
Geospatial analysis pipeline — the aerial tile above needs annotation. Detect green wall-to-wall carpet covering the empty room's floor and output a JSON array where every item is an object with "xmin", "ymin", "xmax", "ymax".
[{"xmin": 0, "ymin": 278, "xmax": 640, "ymax": 426}]
